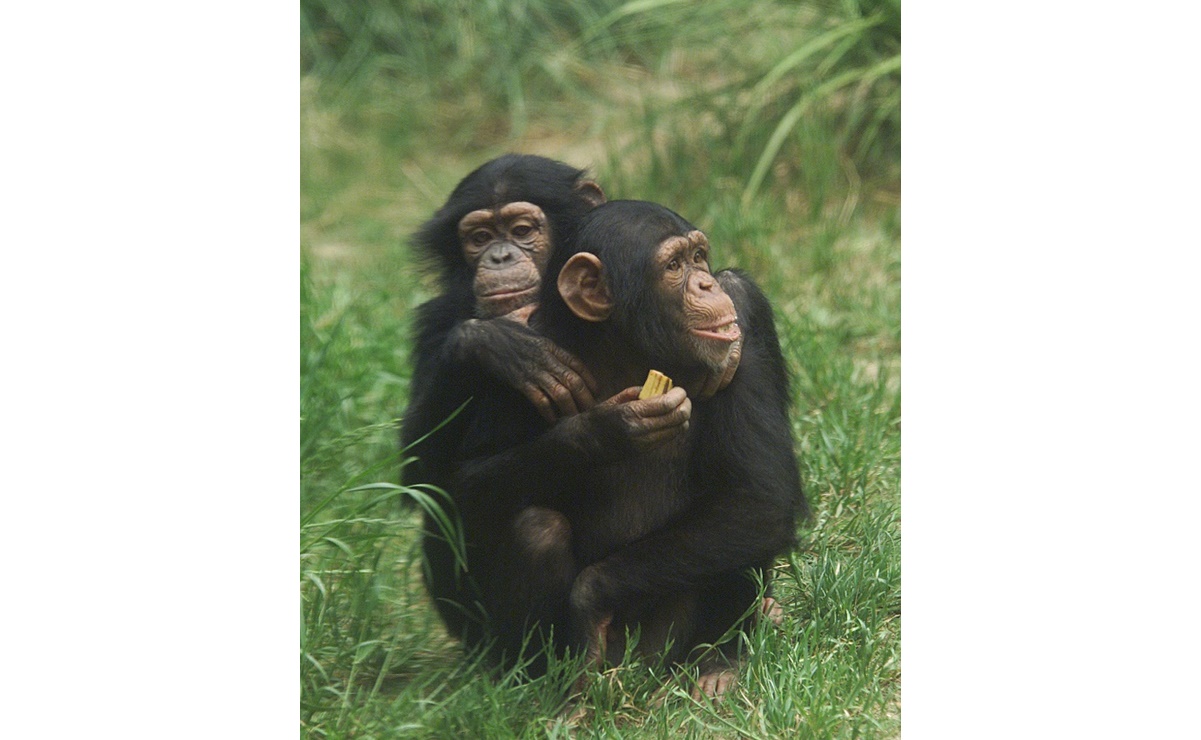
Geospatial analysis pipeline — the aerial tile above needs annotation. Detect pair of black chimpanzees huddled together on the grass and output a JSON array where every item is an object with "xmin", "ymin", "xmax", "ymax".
[{"xmin": 402, "ymin": 155, "xmax": 807, "ymax": 696}]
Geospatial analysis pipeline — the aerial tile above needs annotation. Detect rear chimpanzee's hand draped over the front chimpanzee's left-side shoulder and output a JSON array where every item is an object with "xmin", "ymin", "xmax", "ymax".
[{"xmin": 455, "ymin": 318, "xmax": 597, "ymax": 423}]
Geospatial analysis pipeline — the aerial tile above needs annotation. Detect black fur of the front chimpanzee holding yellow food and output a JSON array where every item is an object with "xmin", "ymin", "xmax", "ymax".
[{"xmin": 425, "ymin": 201, "xmax": 807, "ymax": 670}]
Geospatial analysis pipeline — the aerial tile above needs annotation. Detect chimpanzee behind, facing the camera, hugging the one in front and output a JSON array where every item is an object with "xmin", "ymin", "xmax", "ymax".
[{"xmin": 401, "ymin": 154, "xmax": 605, "ymax": 637}]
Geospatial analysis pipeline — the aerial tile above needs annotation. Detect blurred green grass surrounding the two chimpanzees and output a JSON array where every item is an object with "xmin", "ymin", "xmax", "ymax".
[{"xmin": 300, "ymin": 0, "xmax": 901, "ymax": 738}]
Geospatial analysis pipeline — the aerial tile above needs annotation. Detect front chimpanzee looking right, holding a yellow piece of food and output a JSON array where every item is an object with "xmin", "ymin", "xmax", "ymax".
[{"xmin": 444, "ymin": 201, "xmax": 807, "ymax": 696}]
